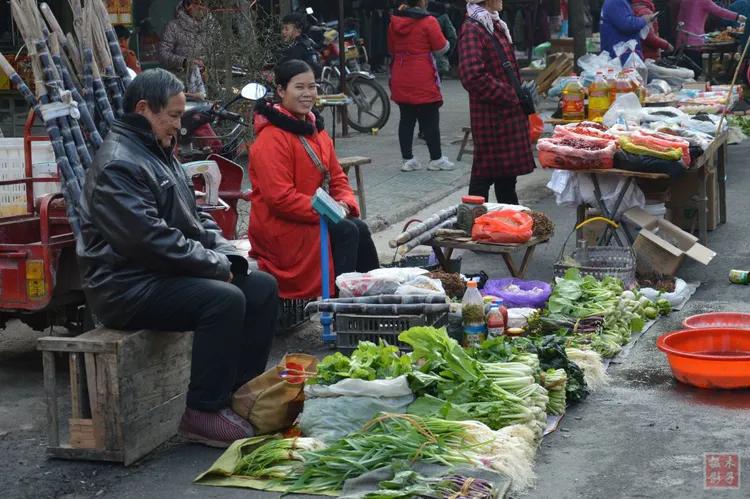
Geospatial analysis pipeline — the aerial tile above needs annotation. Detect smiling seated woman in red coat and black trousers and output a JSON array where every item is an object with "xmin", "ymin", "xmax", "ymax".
[{"xmin": 249, "ymin": 60, "xmax": 380, "ymax": 298}]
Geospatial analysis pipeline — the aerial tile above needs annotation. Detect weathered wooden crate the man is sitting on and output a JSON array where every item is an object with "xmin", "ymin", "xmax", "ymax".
[{"xmin": 38, "ymin": 328, "xmax": 193, "ymax": 466}]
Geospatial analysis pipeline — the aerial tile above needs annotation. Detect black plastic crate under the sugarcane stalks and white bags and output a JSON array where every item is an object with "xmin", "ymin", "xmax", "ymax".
[{"xmin": 334, "ymin": 314, "xmax": 448, "ymax": 353}]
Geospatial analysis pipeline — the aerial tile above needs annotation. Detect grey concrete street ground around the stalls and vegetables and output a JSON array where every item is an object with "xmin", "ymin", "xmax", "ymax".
[{"xmin": 0, "ymin": 82, "xmax": 750, "ymax": 499}]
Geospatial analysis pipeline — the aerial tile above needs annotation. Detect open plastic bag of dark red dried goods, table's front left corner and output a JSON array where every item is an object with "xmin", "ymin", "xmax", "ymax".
[{"xmin": 536, "ymin": 135, "xmax": 617, "ymax": 170}]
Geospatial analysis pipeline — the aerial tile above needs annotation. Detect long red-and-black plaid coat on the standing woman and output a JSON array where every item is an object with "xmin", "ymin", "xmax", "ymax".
[{"xmin": 458, "ymin": 20, "xmax": 535, "ymax": 178}]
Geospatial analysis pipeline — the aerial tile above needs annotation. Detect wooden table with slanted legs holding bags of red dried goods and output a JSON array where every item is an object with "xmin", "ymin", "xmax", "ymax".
[{"xmin": 576, "ymin": 132, "xmax": 729, "ymax": 246}]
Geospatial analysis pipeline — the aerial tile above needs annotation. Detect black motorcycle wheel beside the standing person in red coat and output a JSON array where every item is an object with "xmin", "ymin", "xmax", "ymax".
[{"xmin": 346, "ymin": 78, "xmax": 391, "ymax": 133}]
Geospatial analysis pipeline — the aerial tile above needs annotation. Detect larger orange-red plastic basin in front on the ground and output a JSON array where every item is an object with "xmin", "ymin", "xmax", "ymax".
[{"xmin": 656, "ymin": 328, "xmax": 750, "ymax": 388}]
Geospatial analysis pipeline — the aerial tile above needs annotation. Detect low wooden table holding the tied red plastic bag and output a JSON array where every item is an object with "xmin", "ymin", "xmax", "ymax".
[{"xmin": 426, "ymin": 236, "xmax": 550, "ymax": 278}]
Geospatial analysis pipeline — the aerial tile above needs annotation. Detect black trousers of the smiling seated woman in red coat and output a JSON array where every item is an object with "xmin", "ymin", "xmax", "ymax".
[{"xmin": 328, "ymin": 218, "xmax": 380, "ymax": 276}]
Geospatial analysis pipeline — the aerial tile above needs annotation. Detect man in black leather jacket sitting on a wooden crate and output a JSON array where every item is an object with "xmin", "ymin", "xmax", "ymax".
[{"xmin": 77, "ymin": 69, "xmax": 278, "ymax": 447}]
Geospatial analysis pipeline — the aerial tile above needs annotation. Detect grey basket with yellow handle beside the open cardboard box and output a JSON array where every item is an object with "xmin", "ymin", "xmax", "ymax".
[{"xmin": 554, "ymin": 217, "xmax": 636, "ymax": 287}]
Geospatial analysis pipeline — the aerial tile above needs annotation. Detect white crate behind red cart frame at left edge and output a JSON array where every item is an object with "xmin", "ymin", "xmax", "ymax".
[{"xmin": 0, "ymin": 137, "xmax": 60, "ymax": 217}]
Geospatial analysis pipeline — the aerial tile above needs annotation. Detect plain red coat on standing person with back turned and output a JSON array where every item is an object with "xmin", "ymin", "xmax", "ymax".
[{"xmin": 388, "ymin": 9, "xmax": 448, "ymax": 104}]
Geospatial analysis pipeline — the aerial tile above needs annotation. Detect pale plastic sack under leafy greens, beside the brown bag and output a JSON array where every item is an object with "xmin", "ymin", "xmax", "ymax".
[{"xmin": 299, "ymin": 376, "xmax": 414, "ymax": 442}]
